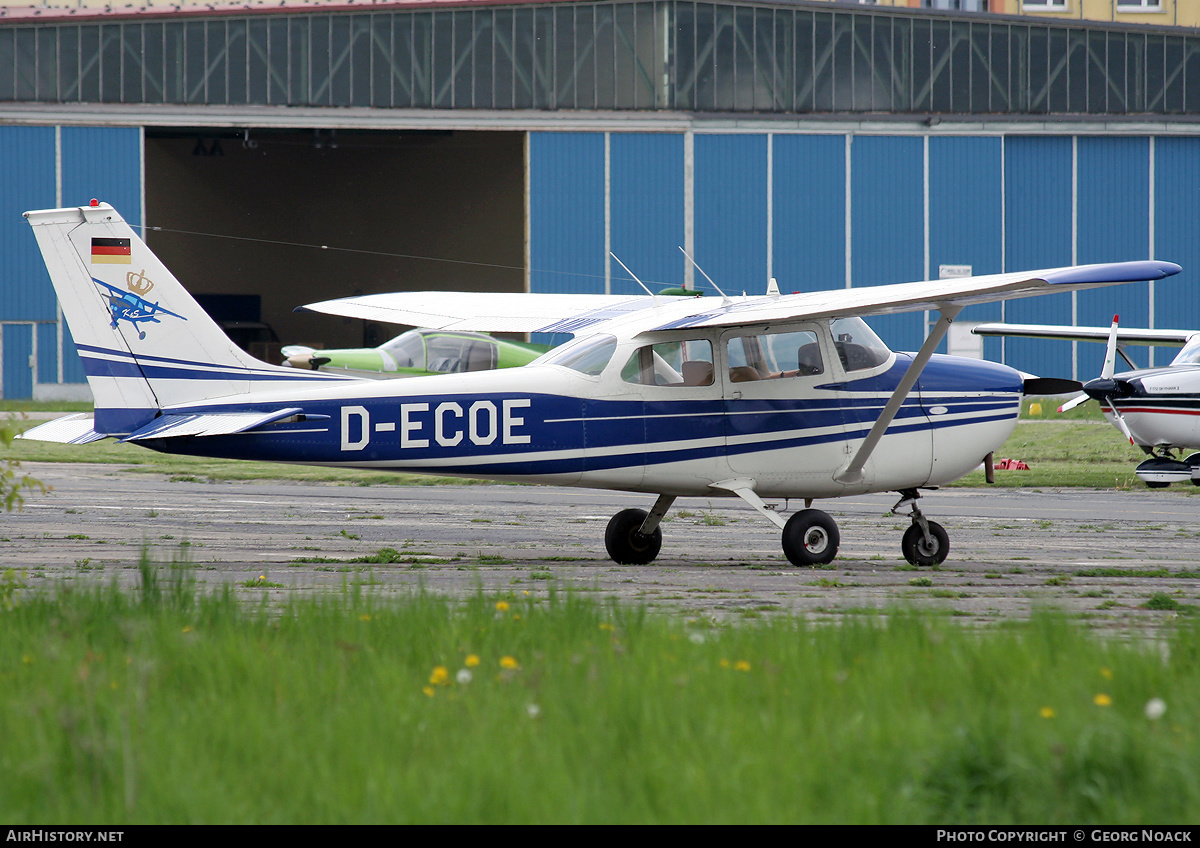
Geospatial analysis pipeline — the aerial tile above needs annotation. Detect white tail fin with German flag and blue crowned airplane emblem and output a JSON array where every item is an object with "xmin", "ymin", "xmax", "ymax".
[{"xmin": 25, "ymin": 202, "xmax": 316, "ymax": 435}]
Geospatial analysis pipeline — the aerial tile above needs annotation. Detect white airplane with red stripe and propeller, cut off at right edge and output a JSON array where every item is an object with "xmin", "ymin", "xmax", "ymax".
[{"xmin": 972, "ymin": 315, "xmax": 1200, "ymax": 488}]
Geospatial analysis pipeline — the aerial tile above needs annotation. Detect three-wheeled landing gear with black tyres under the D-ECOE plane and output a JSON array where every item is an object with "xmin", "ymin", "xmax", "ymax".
[{"xmin": 604, "ymin": 489, "xmax": 950, "ymax": 566}]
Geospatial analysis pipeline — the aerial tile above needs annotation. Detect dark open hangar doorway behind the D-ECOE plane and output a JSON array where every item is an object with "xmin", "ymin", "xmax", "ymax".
[{"xmin": 145, "ymin": 127, "xmax": 526, "ymax": 362}]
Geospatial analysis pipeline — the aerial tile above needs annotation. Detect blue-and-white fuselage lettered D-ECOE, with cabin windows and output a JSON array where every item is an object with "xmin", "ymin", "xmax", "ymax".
[{"xmin": 142, "ymin": 319, "xmax": 1021, "ymax": 498}]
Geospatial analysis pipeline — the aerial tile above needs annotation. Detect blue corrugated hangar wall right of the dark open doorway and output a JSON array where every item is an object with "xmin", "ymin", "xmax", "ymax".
[{"xmin": 529, "ymin": 132, "xmax": 1200, "ymax": 378}]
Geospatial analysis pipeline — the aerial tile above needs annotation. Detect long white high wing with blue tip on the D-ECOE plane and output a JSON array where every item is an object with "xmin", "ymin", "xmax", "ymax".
[{"xmin": 301, "ymin": 260, "xmax": 1181, "ymax": 333}]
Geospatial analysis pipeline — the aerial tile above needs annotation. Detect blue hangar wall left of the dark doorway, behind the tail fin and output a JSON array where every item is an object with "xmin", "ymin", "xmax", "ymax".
[{"xmin": 0, "ymin": 126, "xmax": 142, "ymax": 398}]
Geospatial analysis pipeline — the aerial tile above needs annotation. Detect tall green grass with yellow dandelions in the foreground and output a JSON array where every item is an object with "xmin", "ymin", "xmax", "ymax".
[{"xmin": 0, "ymin": 565, "xmax": 1200, "ymax": 824}]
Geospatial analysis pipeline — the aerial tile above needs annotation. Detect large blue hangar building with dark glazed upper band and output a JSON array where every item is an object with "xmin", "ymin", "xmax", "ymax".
[{"xmin": 0, "ymin": 0, "xmax": 1200, "ymax": 398}]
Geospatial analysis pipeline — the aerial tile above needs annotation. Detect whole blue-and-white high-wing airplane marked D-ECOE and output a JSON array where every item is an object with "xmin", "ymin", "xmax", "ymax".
[{"xmin": 18, "ymin": 202, "xmax": 1180, "ymax": 565}]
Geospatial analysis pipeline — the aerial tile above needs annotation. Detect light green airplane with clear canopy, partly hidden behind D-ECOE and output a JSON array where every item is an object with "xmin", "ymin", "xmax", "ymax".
[{"xmin": 281, "ymin": 330, "xmax": 551, "ymax": 379}]
